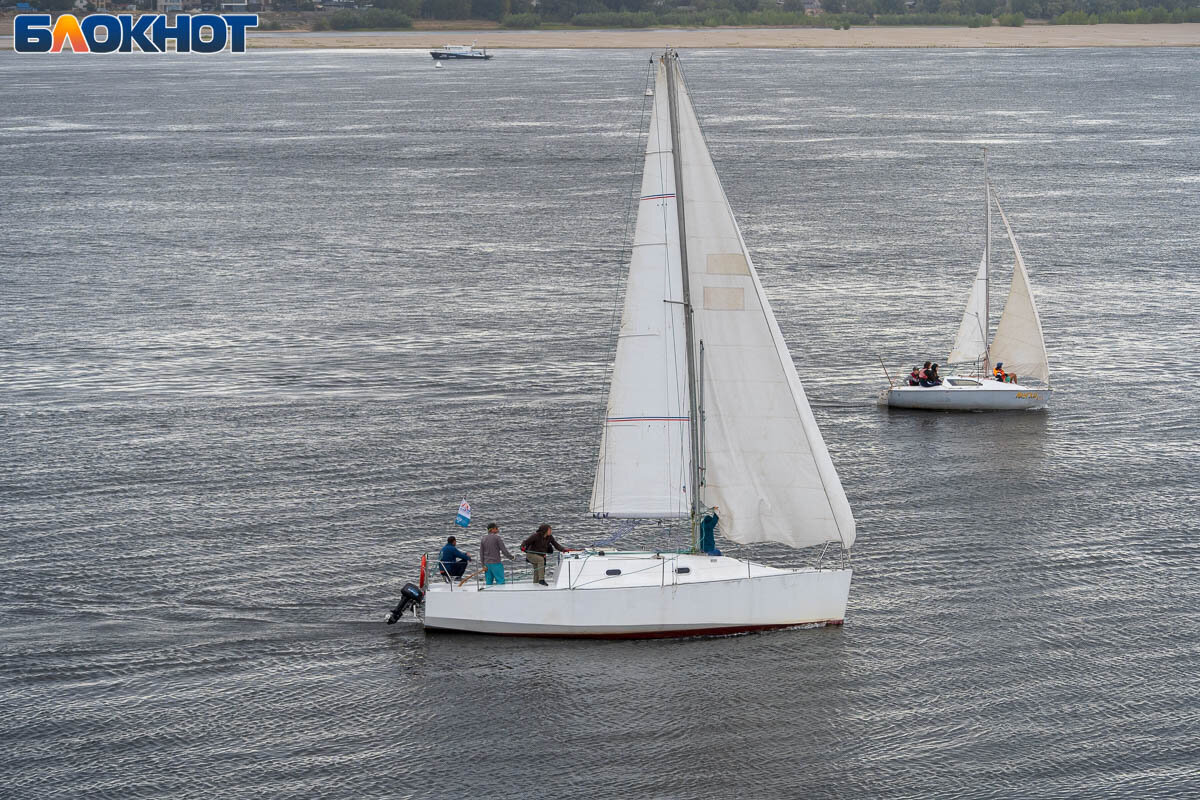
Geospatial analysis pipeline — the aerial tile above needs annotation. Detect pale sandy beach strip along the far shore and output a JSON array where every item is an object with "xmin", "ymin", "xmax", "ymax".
[{"xmin": 250, "ymin": 23, "xmax": 1200, "ymax": 49}]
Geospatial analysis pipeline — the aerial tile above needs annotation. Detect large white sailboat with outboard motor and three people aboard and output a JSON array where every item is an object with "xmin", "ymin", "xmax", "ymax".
[{"xmin": 410, "ymin": 50, "xmax": 854, "ymax": 638}]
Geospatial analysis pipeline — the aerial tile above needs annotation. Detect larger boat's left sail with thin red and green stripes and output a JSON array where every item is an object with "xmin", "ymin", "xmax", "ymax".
[{"xmin": 592, "ymin": 64, "xmax": 691, "ymax": 519}]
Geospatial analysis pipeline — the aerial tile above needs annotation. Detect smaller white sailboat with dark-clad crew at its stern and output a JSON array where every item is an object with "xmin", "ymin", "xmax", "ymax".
[{"xmin": 881, "ymin": 154, "xmax": 1051, "ymax": 411}]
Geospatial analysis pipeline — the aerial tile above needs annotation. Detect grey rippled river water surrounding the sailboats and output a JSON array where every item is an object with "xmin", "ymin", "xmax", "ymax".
[{"xmin": 0, "ymin": 49, "xmax": 1200, "ymax": 798}]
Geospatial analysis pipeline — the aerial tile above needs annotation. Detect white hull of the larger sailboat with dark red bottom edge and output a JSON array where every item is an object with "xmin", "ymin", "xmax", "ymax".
[{"xmin": 425, "ymin": 553, "xmax": 851, "ymax": 638}]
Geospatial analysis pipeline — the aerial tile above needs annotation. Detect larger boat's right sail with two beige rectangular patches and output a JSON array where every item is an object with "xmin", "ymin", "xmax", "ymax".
[{"xmin": 662, "ymin": 62, "xmax": 854, "ymax": 548}]
